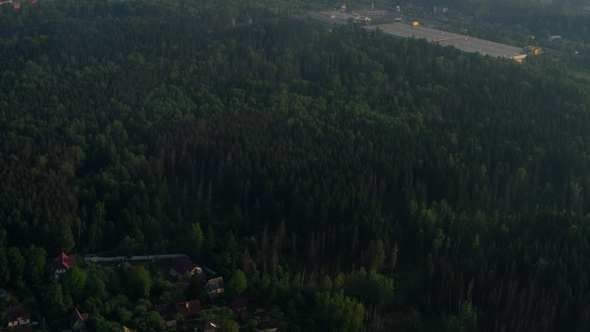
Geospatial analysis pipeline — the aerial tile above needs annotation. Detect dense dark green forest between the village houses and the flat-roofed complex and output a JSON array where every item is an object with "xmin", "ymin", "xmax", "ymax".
[{"xmin": 0, "ymin": 0, "xmax": 590, "ymax": 331}]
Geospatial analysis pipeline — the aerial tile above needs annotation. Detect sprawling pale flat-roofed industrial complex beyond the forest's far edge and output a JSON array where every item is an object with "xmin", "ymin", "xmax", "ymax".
[{"xmin": 310, "ymin": 12, "xmax": 528, "ymax": 62}]
